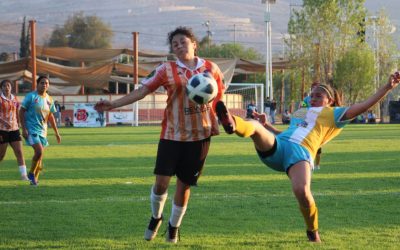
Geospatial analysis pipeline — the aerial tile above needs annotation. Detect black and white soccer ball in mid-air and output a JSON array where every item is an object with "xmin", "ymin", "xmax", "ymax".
[{"xmin": 186, "ymin": 72, "xmax": 218, "ymax": 104}]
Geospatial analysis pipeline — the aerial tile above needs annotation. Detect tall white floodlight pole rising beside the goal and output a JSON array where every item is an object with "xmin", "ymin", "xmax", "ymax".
[{"xmin": 261, "ymin": 0, "xmax": 276, "ymax": 100}]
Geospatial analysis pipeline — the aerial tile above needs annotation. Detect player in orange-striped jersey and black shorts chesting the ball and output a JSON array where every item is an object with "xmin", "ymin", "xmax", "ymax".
[{"xmin": 95, "ymin": 27, "xmax": 225, "ymax": 243}]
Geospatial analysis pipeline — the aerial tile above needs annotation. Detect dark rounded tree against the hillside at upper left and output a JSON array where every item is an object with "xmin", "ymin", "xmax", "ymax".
[{"xmin": 48, "ymin": 12, "xmax": 113, "ymax": 49}]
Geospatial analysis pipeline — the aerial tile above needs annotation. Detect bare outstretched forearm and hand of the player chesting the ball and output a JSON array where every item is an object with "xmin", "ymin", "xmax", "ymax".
[{"xmin": 94, "ymin": 86, "xmax": 150, "ymax": 111}]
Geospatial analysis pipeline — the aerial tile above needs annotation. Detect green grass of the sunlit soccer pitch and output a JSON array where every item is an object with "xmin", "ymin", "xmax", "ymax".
[{"xmin": 0, "ymin": 125, "xmax": 400, "ymax": 249}]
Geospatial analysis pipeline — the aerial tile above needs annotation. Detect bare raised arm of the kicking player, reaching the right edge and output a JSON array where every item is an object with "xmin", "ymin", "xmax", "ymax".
[{"xmin": 343, "ymin": 72, "xmax": 400, "ymax": 120}]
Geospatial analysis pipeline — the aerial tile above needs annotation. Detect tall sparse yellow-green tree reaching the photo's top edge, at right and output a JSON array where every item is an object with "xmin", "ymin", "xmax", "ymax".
[{"xmin": 288, "ymin": 0, "xmax": 366, "ymax": 87}]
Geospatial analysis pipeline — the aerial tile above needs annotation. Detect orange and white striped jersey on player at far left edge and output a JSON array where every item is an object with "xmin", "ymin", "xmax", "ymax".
[{"xmin": 0, "ymin": 94, "xmax": 19, "ymax": 131}]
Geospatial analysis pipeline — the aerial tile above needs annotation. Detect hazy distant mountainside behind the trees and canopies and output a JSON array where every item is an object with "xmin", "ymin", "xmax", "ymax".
[{"xmin": 0, "ymin": 0, "xmax": 400, "ymax": 53}]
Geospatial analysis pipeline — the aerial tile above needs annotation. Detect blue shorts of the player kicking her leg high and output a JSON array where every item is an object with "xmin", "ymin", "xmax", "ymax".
[{"xmin": 258, "ymin": 136, "xmax": 314, "ymax": 173}]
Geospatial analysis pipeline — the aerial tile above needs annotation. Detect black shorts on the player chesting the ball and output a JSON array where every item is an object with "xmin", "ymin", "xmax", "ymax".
[{"xmin": 154, "ymin": 137, "xmax": 211, "ymax": 186}]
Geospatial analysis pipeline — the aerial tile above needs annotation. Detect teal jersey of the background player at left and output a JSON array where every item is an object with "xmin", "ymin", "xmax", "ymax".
[{"xmin": 22, "ymin": 91, "xmax": 56, "ymax": 137}]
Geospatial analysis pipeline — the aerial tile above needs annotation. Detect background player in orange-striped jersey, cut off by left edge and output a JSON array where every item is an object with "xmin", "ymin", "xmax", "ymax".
[{"xmin": 0, "ymin": 80, "xmax": 28, "ymax": 180}]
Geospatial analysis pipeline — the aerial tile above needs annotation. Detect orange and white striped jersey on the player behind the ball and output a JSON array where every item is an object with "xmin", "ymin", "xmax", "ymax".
[{"xmin": 142, "ymin": 57, "xmax": 225, "ymax": 141}]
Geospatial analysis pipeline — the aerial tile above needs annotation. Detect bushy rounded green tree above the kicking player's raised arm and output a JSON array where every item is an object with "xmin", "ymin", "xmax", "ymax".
[{"xmin": 334, "ymin": 44, "xmax": 376, "ymax": 104}]
